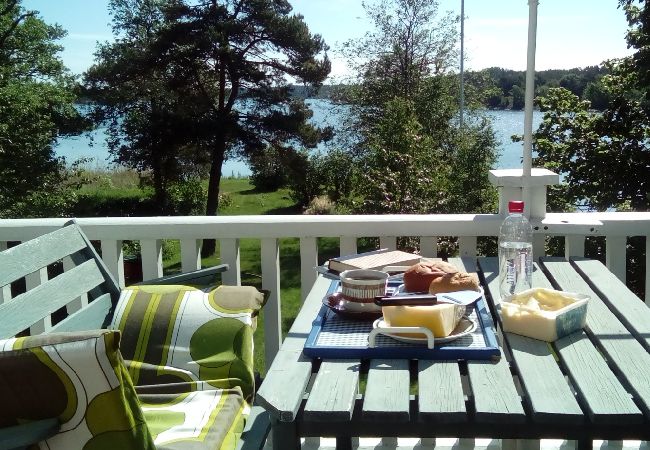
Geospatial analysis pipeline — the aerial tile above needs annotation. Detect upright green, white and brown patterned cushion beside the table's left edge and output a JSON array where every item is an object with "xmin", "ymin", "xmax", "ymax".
[{"xmin": 112, "ymin": 285, "xmax": 264, "ymax": 399}]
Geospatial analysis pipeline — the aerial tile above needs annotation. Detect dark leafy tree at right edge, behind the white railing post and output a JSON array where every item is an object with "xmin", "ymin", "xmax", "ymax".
[{"xmin": 535, "ymin": 0, "xmax": 650, "ymax": 211}]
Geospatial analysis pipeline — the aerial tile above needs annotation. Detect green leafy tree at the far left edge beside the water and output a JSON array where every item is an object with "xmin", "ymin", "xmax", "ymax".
[{"xmin": 0, "ymin": 0, "xmax": 85, "ymax": 216}]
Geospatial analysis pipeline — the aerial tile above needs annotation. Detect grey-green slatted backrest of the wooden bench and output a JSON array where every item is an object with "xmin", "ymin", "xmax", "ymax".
[{"xmin": 0, "ymin": 221, "xmax": 120, "ymax": 339}]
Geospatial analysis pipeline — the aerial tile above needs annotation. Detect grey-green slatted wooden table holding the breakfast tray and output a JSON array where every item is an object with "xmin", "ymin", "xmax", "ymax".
[{"xmin": 257, "ymin": 258, "xmax": 650, "ymax": 450}]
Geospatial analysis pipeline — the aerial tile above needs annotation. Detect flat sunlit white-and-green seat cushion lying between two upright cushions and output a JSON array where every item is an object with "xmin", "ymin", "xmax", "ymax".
[{"xmin": 137, "ymin": 382, "xmax": 249, "ymax": 450}]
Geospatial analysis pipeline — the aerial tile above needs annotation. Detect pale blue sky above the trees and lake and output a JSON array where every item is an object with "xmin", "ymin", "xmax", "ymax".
[{"xmin": 22, "ymin": 0, "xmax": 631, "ymax": 80}]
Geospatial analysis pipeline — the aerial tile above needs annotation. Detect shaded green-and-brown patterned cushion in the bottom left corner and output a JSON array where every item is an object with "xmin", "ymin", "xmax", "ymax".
[{"xmin": 0, "ymin": 330, "xmax": 154, "ymax": 450}]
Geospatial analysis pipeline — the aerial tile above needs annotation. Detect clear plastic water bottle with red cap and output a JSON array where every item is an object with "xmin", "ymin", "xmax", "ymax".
[{"xmin": 499, "ymin": 200, "xmax": 533, "ymax": 298}]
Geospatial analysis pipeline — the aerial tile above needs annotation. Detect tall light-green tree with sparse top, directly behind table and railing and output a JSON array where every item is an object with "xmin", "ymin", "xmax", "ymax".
[{"xmin": 324, "ymin": 0, "xmax": 496, "ymax": 219}]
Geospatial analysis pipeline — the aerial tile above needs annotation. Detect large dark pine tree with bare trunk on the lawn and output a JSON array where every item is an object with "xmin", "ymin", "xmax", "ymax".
[{"xmin": 86, "ymin": 0, "xmax": 330, "ymax": 214}]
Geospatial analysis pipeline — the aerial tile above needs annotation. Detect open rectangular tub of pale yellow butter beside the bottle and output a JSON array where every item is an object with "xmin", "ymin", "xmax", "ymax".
[{"xmin": 501, "ymin": 288, "xmax": 589, "ymax": 342}]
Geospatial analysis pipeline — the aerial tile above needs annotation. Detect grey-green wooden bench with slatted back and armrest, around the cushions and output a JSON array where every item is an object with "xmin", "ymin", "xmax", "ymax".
[{"xmin": 0, "ymin": 222, "xmax": 270, "ymax": 450}]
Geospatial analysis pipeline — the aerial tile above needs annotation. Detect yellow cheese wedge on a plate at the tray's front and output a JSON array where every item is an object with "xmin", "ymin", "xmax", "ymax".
[{"xmin": 381, "ymin": 303, "xmax": 465, "ymax": 338}]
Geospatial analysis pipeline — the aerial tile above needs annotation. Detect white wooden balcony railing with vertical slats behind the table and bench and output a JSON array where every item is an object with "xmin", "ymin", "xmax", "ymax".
[{"xmin": 0, "ymin": 212, "xmax": 650, "ymax": 367}]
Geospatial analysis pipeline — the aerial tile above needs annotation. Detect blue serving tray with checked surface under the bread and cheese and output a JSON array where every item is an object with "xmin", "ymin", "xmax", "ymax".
[{"xmin": 303, "ymin": 279, "xmax": 501, "ymax": 360}]
